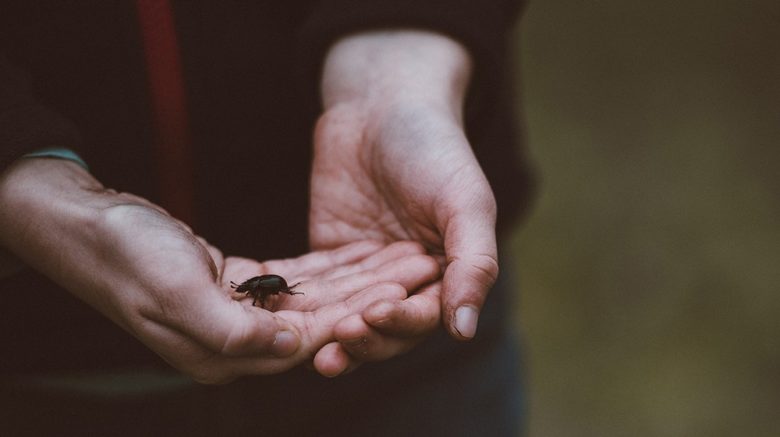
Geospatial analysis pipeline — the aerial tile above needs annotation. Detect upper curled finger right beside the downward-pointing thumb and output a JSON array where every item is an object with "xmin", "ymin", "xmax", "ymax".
[{"xmin": 362, "ymin": 282, "xmax": 441, "ymax": 338}]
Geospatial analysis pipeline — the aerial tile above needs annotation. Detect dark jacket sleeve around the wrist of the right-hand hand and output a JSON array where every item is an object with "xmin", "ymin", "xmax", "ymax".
[{"xmin": 298, "ymin": 0, "xmax": 523, "ymax": 133}]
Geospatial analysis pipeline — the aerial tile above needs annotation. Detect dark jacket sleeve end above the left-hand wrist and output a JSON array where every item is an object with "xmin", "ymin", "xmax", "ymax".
[{"xmin": 0, "ymin": 56, "xmax": 81, "ymax": 172}]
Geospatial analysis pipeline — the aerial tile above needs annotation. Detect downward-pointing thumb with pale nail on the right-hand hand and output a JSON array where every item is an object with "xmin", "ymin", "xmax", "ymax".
[{"xmin": 442, "ymin": 196, "xmax": 498, "ymax": 340}]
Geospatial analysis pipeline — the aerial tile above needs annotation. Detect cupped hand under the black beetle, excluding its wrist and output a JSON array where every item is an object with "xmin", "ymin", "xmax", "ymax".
[{"xmin": 102, "ymin": 205, "xmax": 438, "ymax": 382}]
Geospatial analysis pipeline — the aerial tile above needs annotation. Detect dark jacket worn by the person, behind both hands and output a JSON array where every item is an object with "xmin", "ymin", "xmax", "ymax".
[{"xmin": 0, "ymin": 0, "xmax": 530, "ymax": 372}]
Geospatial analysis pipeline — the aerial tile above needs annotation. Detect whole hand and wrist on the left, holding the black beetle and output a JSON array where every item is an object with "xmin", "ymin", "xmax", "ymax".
[{"xmin": 0, "ymin": 159, "xmax": 439, "ymax": 383}]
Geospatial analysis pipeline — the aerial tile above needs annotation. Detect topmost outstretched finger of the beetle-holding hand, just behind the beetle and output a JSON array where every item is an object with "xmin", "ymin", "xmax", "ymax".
[{"xmin": 261, "ymin": 240, "xmax": 385, "ymax": 280}]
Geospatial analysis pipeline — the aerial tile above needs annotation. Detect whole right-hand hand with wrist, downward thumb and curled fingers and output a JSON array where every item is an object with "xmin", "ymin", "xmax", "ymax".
[{"xmin": 310, "ymin": 30, "xmax": 498, "ymax": 374}]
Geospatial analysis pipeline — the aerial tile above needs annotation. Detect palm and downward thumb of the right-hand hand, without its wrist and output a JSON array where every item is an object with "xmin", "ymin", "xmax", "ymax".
[{"xmin": 310, "ymin": 105, "xmax": 498, "ymax": 344}]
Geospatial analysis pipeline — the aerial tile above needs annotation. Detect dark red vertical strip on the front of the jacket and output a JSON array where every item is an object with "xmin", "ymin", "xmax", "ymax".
[{"xmin": 136, "ymin": 0, "xmax": 194, "ymax": 225}]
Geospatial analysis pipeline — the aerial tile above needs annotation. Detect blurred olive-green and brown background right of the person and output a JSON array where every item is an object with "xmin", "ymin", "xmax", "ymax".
[{"xmin": 513, "ymin": 0, "xmax": 780, "ymax": 436}]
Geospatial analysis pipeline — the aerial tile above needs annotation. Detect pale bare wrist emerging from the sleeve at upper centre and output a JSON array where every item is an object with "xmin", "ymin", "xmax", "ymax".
[{"xmin": 322, "ymin": 30, "xmax": 471, "ymax": 120}]
